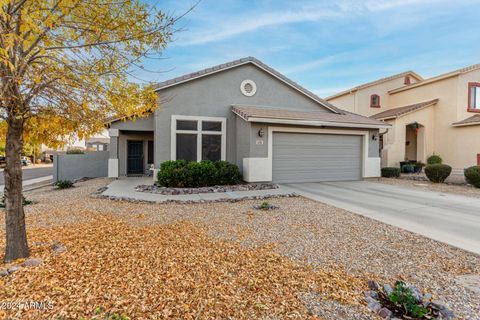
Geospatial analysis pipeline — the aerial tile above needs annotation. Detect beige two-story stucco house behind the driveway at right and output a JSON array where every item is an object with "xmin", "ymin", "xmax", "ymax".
[{"xmin": 326, "ymin": 64, "xmax": 480, "ymax": 172}]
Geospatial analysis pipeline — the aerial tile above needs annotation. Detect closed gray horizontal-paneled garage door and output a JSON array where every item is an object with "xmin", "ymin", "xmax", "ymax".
[{"xmin": 273, "ymin": 133, "xmax": 362, "ymax": 182}]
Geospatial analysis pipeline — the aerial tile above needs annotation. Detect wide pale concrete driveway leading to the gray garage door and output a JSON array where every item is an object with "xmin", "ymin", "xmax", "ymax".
[{"xmin": 282, "ymin": 181, "xmax": 480, "ymax": 254}]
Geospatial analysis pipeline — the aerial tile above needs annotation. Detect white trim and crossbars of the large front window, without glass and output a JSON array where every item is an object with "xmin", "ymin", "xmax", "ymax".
[{"xmin": 170, "ymin": 115, "xmax": 227, "ymax": 161}]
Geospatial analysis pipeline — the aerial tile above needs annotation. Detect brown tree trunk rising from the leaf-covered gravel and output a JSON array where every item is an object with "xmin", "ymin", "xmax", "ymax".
[{"xmin": 5, "ymin": 115, "xmax": 29, "ymax": 262}]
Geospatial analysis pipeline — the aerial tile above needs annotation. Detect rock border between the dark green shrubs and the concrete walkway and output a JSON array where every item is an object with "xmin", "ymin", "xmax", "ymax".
[{"xmin": 135, "ymin": 183, "xmax": 278, "ymax": 196}]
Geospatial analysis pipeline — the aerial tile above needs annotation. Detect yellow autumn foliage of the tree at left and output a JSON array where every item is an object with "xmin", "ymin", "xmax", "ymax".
[{"xmin": 0, "ymin": 0, "xmax": 175, "ymax": 146}]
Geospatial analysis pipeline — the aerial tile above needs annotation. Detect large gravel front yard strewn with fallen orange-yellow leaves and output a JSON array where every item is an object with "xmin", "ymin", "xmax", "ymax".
[{"xmin": 0, "ymin": 179, "xmax": 480, "ymax": 319}]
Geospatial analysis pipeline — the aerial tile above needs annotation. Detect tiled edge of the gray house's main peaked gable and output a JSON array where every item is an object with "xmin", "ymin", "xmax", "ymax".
[{"xmin": 154, "ymin": 57, "xmax": 344, "ymax": 113}]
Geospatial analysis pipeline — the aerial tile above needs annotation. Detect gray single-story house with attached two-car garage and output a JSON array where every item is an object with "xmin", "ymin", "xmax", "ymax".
[{"xmin": 108, "ymin": 57, "xmax": 390, "ymax": 183}]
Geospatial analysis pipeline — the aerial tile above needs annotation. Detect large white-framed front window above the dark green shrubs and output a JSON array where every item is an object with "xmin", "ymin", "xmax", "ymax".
[{"xmin": 171, "ymin": 115, "xmax": 227, "ymax": 161}]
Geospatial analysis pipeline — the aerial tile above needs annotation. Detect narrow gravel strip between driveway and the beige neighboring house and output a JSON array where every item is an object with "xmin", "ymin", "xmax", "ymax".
[{"xmin": 372, "ymin": 176, "xmax": 480, "ymax": 198}]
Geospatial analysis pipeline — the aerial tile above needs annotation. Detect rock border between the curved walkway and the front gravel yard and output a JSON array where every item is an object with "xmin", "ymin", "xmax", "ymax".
[{"xmin": 91, "ymin": 190, "xmax": 300, "ymax": 204}]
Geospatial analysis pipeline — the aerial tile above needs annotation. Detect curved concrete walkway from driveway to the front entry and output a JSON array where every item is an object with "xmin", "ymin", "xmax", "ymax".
[{"xmin": 101, "ymin": 177, "xmax": 292, "ymax": 203}]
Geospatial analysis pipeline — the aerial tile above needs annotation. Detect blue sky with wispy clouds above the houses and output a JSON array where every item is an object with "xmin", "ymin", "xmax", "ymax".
[{"xmin": 136, "ymin": 0, "xmax": 480, "ymax": 97}]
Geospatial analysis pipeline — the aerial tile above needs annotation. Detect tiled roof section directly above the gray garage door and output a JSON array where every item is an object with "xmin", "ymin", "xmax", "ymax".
[{"xmin": 232, "ymin": 105, "xmax": 390, "ymax": 128}]
